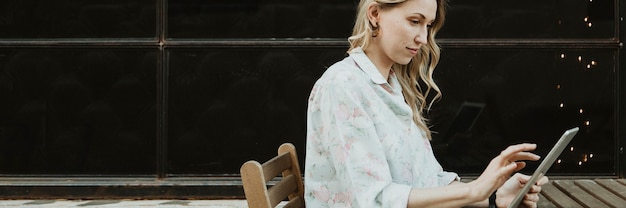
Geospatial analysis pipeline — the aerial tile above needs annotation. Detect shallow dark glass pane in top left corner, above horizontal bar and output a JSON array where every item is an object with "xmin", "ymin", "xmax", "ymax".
[{"xmin": 0, "ymin": 0, "xmax": 158, "ymax": 39}]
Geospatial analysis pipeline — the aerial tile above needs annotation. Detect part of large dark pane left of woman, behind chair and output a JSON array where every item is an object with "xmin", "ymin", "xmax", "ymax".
[{"xmin": 167, "ymin": 47, "xmax": 346, "ymax": 174}]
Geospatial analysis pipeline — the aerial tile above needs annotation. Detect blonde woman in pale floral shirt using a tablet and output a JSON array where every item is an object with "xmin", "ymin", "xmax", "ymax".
[{"xmin": 305, "ymin": 0, "xmax": 548, "ymax": 207}]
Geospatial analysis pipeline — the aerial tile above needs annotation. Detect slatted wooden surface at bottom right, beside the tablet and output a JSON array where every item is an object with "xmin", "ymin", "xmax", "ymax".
[{"xmin": 538, "ymin": 179, "xmax": 626, "ymax": 208}]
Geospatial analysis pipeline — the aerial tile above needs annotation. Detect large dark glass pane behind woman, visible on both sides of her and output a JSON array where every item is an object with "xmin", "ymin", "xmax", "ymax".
[{"xmin": 168, "ymin": 47, "xmax": 615, "ymax": 175}]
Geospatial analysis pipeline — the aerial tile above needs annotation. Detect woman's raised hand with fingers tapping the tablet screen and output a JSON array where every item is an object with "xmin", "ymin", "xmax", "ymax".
[{"xmin": 470, "ymin": 143, "xmax": 540, "ymax": 201}]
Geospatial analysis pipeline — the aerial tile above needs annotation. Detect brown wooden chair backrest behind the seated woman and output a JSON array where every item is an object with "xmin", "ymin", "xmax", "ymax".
[{"xmin": 241, "ymin": 143, "xmax": 304, "ymax": 208}]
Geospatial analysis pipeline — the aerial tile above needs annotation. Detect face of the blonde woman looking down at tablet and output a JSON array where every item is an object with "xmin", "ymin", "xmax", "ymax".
[{"xmin": 374, "ymin": 0, "xmax": 437, "ymax": 65}]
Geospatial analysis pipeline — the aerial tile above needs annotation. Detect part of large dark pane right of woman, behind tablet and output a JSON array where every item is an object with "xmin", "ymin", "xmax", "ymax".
[{"xmin": 430, "ymin": 49, "xmax": 617, "ymax": 175}]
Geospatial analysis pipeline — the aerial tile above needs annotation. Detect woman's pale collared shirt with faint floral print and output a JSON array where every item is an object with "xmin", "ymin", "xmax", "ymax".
[{"xmin": 304, "ymin": 48, "xmax": 458, "ymax": 208}]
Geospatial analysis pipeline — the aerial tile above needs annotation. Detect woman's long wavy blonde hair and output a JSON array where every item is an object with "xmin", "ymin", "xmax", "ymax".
[{"xmin": 348, "ymin": 0, "xmax": 447, "ymax": 139}]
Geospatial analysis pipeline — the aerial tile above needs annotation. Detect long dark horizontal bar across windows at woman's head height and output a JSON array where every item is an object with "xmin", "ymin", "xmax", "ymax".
[{"xmin": 0, "ymin": 38, "xmax": 622, "ymax": 49}]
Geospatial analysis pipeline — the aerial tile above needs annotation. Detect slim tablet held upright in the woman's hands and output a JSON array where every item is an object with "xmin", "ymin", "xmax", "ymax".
[{"xmin": 509, "ymin": 127, "xmax": 578, "ymax": 208}]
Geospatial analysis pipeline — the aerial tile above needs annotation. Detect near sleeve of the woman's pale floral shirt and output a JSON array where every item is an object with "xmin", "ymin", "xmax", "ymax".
[{"xmin": 310, "ymin": 80, "xmax": 411, "ymax": 207}]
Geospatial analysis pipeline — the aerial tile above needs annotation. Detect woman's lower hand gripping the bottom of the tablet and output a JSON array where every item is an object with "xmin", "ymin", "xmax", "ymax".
[{"xmin": 496, "ymin": 173, "xmax": 548, "ymax": 208}]
